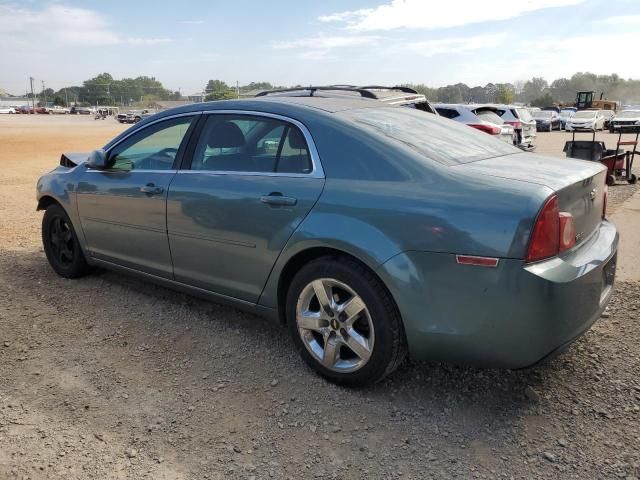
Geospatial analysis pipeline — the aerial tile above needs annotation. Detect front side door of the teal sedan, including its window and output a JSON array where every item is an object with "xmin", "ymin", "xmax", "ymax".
[{"xmin": 77, "ymin": 114, "xmax": 196, "ymax": 278}]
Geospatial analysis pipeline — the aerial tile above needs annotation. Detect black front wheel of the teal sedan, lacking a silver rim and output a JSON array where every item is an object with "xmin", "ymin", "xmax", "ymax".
[{"xmin": 42, "ymin": 204, "xmax": 89, "ymax": 278}]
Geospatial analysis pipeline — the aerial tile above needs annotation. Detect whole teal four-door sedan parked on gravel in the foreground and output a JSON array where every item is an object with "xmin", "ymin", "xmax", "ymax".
[{"xmin": 37, "ymin": 97, "xmax": 618, "ymax": 385}]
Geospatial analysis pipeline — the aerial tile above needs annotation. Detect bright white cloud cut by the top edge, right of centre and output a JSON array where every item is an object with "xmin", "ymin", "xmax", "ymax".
[{"xmin": 318, "ymin": 0, "xmax": 585, "ymax": 31}]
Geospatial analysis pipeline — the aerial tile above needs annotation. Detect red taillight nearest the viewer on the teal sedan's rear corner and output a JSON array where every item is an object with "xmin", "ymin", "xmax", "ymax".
[{"xmin": 526, "ymin": 195, "xmax": 576, "ymax": 262}]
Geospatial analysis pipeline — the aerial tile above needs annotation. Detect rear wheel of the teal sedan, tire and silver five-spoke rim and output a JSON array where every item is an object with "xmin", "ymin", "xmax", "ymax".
[{"xmin": 286, "ymin": 257, "xmax": 407, "ymax": 386}]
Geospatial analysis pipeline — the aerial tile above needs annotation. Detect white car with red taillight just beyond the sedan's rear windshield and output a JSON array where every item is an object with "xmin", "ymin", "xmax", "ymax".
[{"xmin": 434, "ymin": 103, "xmax": 515, "ymax": 144}]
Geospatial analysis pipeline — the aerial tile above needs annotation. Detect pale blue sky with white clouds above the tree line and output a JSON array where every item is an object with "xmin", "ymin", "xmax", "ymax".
[{"xmin": 0, "ymin": 0, "xmax": 640, "ymax": 94}]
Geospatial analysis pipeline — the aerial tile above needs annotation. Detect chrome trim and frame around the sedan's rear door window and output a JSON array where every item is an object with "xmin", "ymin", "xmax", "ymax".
[{"xmin": 178, "ymin": 110, "xmax": 325, "ymax": 178}]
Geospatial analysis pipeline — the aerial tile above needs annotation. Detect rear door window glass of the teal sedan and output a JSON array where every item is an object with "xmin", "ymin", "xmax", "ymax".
[{"xmin": 191, "ymin": 114, "xmax": 312, "ymax": 173}]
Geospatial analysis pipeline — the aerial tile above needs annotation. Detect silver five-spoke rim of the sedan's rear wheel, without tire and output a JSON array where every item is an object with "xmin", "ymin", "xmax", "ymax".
[{"xmin": 296, "ymin": 278, "xmax": 375, "ymax": 373}]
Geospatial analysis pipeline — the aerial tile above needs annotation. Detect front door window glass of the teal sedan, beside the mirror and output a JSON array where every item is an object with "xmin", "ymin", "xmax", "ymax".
[{"xmin": 109, "ymin": 117, "xmax": 193, "ymax": 170}]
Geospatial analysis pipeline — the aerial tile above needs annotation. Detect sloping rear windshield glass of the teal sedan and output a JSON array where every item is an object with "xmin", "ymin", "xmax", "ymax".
[{"xmin": 339, "ymin": 108, "xmax": 521, "ymax": 165}]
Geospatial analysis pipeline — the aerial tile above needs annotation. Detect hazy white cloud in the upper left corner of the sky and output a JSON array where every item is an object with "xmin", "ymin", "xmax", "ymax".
[{"xmin": 0, "ymin": 4, "xmax": 171, "ymax": 50}]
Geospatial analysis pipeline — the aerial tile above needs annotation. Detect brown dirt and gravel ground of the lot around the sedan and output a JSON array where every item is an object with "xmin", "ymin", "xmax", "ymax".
[{"xmin": 0, "ymin": 115, "xmax": 640, "ymax": 480}]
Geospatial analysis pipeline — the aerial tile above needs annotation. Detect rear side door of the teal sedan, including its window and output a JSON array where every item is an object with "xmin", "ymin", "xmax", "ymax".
[{"xmin": 167, "ymin": 113, "xmax": 324, "ymax": 302}]
